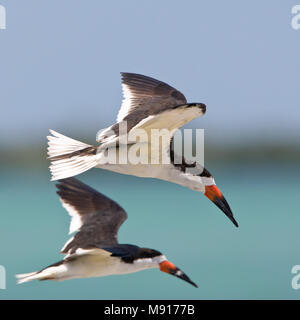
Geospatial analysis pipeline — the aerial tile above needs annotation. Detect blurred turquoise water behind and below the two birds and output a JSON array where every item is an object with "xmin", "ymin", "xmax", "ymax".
[{"xmin": 0, "ymin": 164, "xmax": 300, "ymax": 299}]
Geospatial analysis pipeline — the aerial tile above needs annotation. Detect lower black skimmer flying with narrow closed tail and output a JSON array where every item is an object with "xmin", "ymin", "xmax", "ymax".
[{"xmin": 16, "ymin": 178, "xmax": 197, "ymax": 287}]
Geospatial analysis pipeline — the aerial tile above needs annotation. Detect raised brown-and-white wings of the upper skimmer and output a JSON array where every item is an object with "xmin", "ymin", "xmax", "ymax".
[{"xmin": 96, "ymin": 73, "xmax": 205, "ymax": 143}]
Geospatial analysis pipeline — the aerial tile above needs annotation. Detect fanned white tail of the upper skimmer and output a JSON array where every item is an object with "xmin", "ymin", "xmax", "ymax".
[{"xmin": 47, "ymin": 130, "xmax": 97, "ymax": 180}]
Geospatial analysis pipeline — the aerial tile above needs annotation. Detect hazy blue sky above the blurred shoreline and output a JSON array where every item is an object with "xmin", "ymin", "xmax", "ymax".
[{"xmin": 0, "ymin": 0, "xmax": 300, "ymax": 145}]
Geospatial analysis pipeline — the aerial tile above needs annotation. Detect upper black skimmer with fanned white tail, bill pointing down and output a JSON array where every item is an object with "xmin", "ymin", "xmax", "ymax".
[{"xmin": 47, "ymin": 73, "xmax": 238, "ymax": 227}]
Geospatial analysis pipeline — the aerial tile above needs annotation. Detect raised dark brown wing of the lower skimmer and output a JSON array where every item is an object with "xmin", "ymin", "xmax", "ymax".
[{"xmin": 56, "ymin": 178, "xmax": 127, "ymax": 254}]
